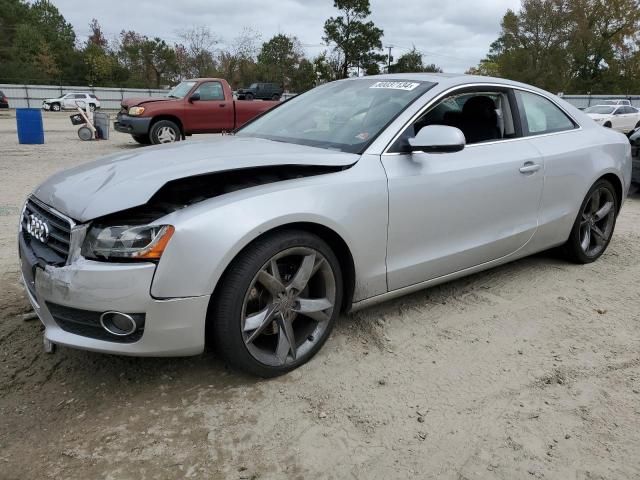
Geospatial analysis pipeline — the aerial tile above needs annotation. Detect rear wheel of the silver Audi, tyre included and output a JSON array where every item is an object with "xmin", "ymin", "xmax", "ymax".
[{"xmin": 564, "ymin": 180, "xmax": 619, "ymax": 263}]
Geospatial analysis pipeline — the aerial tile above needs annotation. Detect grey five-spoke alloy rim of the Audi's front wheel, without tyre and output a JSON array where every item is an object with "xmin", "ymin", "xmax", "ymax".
[{"xmin": 241, "ymin": 247, "xmax": 336, "ymax": 366}]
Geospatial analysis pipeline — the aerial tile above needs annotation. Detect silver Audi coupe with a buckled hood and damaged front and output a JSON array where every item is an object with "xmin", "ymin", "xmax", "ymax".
[{"xmin": 19, "ymin": 74, "xmax": 631, "ymax": 377}]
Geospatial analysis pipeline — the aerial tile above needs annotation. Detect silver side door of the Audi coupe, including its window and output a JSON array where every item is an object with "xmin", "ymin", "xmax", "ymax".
[{"xmin": 382, "ymin": 90, "xmax": 544, "ymax": 290}]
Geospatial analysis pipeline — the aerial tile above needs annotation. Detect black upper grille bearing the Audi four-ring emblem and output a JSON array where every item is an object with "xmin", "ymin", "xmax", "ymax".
[{"xmin": 21, "ymin": 198, "xmax": 71, "ymax": 265}]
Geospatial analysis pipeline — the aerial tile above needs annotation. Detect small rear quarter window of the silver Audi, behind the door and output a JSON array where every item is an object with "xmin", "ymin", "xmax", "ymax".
[{"xmin": 516, "ymin": 91, "xmax": 576, "ymax": 135}]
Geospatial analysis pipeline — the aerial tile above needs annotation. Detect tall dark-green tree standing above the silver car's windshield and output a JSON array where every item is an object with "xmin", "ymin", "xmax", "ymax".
[{"xmin": 322, "ymin": 0, "xmax": 383, "ymax": 78}]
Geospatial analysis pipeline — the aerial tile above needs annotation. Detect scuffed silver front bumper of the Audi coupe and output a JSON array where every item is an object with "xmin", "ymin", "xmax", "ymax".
[{"xmin": 19, "ymin": 235, "xmax": 209, "ymax": 356}]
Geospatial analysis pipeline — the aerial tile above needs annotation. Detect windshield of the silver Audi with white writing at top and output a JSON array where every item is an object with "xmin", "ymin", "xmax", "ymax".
[{"xmin": 238, "ymin": 79, "xmax": 435, "ymax": 153}]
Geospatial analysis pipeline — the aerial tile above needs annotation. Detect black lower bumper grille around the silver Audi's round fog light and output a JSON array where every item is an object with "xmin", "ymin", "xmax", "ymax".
[{"xmin": 47, "ymin": 302, "xmax": 145, "ymax": 343}]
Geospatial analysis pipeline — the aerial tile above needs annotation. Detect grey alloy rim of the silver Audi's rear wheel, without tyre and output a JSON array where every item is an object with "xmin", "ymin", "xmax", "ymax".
[{"xmin": 580, "ymin": 187, "xmax": 616, "ymax": 257}]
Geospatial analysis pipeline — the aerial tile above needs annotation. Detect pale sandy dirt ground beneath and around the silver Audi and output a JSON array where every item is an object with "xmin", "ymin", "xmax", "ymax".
[{"xmin": 0, "ymin": 113, "xmax": 640, "ymax": 480}]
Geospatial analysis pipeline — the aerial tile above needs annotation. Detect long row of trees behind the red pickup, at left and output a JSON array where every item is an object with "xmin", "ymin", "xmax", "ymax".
[{"xmin": 0, "ymin": 0, "xmax": 438, "ymax": 92}]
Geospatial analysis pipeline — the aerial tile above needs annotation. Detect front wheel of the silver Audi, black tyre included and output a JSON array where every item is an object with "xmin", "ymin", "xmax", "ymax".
[{"xmin": 209, "ymin": 230, "xmax": 342, "ymax": 378}]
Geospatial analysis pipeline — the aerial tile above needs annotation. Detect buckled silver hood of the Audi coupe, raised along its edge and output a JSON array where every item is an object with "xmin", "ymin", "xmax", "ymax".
[{"xmin": 34, "ymin": 136, "xmax": 360, "ymax": 222}]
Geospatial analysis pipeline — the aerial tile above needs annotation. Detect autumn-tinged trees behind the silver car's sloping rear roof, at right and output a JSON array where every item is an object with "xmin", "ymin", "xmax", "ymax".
[{"xmin": 469, "ymin": 0, "xmax": 640, "ymax": 95}]
